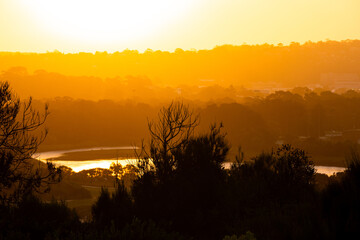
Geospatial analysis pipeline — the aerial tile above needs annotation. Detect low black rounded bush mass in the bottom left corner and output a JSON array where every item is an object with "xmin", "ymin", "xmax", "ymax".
[{"xmin": 0, "ymin": 195, "xmax": 80, "ymax": 240}]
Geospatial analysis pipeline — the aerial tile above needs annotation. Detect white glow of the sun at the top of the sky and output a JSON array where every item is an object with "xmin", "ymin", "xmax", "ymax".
[{"xmin": 18, "ymin": 0, "xmax": 196, "ymax": 44}]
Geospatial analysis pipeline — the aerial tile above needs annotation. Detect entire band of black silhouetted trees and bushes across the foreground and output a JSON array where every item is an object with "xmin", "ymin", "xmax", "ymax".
[{"xmin": 0, "ymin": 84, "xmax": 360, "ymax": 239}]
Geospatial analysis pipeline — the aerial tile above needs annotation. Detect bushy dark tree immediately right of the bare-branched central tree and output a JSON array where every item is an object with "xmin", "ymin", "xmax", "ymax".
[{"xmin": 167, "ymin": 124, "xmax": 229, "ymax": 239}]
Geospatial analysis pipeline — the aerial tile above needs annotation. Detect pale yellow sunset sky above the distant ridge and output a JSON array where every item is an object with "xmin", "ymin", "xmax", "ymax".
[{"xmin": 0, "ymin": 0, "xmax": 360, "ymax": 52}]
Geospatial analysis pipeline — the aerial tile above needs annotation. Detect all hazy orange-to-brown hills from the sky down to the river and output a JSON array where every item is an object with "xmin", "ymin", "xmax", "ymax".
[{"xmin": 0, "ymin": 40, "xmax": 360, "ymax": 166}]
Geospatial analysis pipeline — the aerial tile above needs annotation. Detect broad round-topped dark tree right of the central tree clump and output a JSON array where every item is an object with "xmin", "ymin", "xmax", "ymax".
[{"xmin": 224, "ymin": 145, "xmax": 324, "ymax": 239}]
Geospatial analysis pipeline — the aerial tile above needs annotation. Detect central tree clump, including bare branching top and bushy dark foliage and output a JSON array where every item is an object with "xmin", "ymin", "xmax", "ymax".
[{"xmin": 132, "ymin": 103, "xmax": 229, "ymax": 238}]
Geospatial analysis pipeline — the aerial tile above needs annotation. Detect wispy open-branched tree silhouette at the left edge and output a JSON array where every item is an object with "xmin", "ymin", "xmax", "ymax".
[{"xmin": 0, "ymin": 82, "xmax": 61, "ymax": 204}]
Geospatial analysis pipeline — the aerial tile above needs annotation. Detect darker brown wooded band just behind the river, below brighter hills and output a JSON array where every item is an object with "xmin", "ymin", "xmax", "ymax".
[{"xmin": 28, "ymin": 89, "xmax": 360, "ymax": 166}]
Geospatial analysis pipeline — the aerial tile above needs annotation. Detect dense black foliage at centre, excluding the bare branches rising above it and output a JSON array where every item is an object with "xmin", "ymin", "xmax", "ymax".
[{"xmin": 133, "ymin": 121, "xmax": 229, "ymax": 238}]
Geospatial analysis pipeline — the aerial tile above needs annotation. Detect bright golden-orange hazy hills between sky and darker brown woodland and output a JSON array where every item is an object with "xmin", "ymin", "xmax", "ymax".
[{"xmin": 0, "ymin": 40, "xmax": 360, "ymax": 95}]
